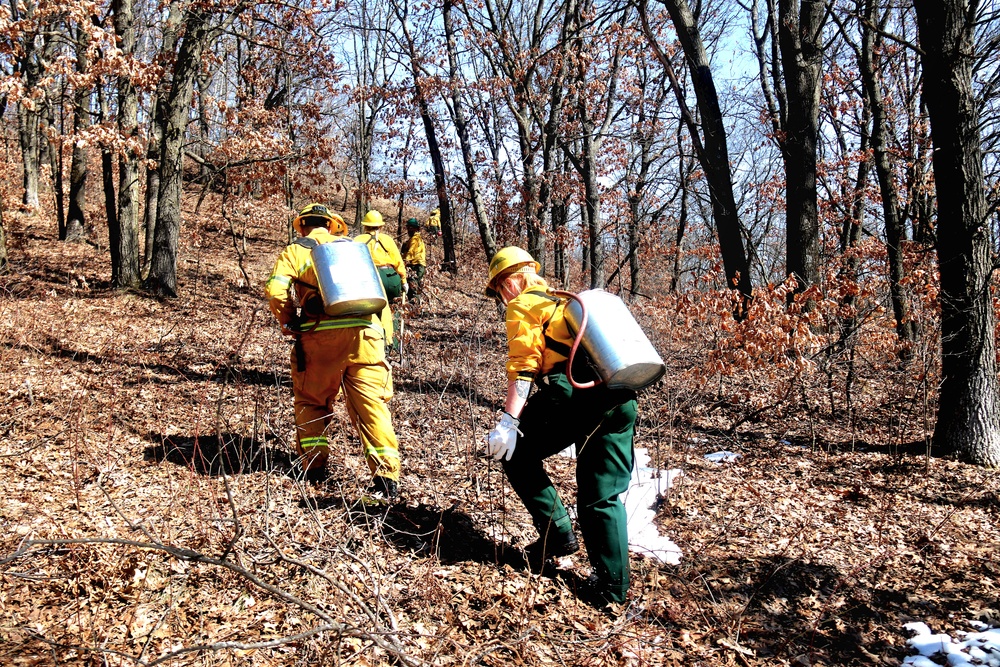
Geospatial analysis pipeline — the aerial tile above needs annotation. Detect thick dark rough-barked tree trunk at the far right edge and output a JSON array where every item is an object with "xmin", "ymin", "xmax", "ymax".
[{"xmin": 914, "ymin": 0, "xmax": 1000, "ymax": 467}]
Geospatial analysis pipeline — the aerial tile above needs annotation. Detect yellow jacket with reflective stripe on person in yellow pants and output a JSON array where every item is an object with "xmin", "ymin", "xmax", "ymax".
[{"xmin": 264, "ymin": 227, "xmax": 381, "ymax": 333}]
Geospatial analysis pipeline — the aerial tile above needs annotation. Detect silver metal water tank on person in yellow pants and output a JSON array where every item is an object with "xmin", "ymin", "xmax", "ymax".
[{"xmin": 312, "ymin": 238, "xmax": 388, "ymax": 317}]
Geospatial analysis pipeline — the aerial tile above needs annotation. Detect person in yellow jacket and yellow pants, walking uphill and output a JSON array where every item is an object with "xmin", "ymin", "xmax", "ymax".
[{"xmin": 264, "ymin": 204, "xmax": 400, "ymax": 498}]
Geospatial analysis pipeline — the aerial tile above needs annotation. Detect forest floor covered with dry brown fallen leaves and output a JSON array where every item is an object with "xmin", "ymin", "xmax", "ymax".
[{"xmin": 0, "ymin": 190, "xmax": 1000, "ymax": 667}]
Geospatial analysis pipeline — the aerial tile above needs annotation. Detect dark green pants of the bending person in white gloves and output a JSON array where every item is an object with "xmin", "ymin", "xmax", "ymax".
[{"xmin": 503, "ymin": 373, "xmax": 636, "ymax": 602}]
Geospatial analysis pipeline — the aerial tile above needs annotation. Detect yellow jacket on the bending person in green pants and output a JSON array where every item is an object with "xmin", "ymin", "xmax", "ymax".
[{"xmin": 506, "ymin": 281, "xmax": 573, "ymax": 380}]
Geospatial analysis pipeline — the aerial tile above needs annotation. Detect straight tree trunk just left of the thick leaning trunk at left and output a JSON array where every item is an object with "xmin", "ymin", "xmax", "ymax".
[{"xmin": 111, "ymin": 0, "xmax": 141, "ymax": 289}]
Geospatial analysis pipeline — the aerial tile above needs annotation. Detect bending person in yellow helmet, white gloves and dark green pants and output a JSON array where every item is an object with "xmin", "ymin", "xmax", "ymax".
[{"xmin": 486, "ymin": 247, "xmax": 636, "ymax": 606}]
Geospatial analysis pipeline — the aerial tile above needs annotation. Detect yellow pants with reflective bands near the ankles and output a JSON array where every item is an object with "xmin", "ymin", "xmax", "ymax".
[{"xmin": 292, "ymin": 327, "xmax": 400, "ymax": 481}]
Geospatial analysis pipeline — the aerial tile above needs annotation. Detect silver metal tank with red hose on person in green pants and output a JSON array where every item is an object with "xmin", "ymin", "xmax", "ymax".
[{"xmin": 566, "ymin": 289, "xmax": 667, "ymax": 391}]
